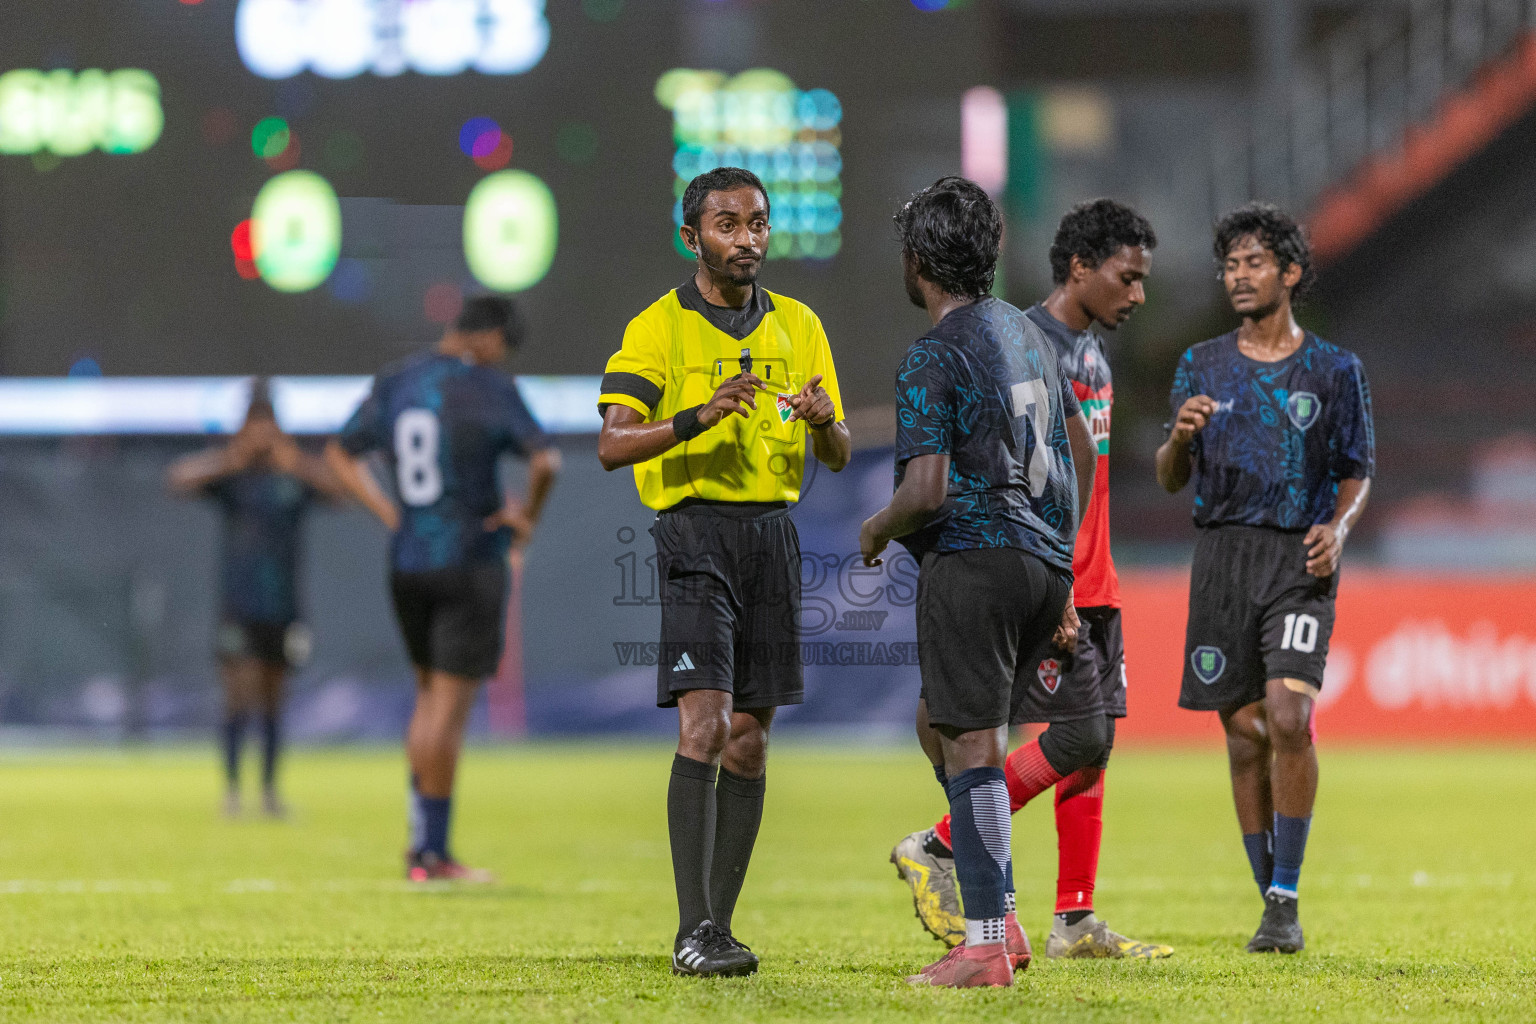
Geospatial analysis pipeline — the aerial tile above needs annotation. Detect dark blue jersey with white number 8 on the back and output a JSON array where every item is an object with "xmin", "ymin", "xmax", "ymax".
[{"xmin": 339, "ymin": 352, "xmax": 550, "ymax": 573}]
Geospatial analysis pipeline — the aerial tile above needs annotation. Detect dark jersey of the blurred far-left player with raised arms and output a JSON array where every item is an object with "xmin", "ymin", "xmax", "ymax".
[{"xmin": 203, "ymin": 470, "xmax": 315, "ymax": 626}]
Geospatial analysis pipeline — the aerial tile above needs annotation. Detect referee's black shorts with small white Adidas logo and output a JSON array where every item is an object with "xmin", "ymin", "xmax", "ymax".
[{"xmin": 651, "ymin": 504, "xmax": 805, "ymax": 711}]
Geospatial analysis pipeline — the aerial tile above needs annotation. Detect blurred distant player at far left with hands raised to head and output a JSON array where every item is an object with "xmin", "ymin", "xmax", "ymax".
[{"xmin": 169, "ymin": 379, "xmax": 343, "ymax": 817}]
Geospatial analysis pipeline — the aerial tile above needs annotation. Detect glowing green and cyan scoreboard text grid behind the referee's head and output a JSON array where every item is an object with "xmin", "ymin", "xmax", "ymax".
[{"xmin": 656, "ymin": 68, "xmax": 843, "ymax": 259}]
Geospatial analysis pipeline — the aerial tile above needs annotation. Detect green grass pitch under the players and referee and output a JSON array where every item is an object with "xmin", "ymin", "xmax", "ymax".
[{"xmin": 0, "ymin": 743, "xmax": 1536, "ymax": 1024}]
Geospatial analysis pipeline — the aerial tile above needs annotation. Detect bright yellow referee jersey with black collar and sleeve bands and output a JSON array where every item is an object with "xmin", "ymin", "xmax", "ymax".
[{"xmin": 598, "ymin": 276, "xmax": 843, "ymax": 508}]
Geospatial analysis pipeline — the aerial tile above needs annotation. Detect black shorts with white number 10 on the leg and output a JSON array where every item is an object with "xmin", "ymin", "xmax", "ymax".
[{"xmin": 1178, "ymin": 525, "xmax": 1339, "ymax": 711}]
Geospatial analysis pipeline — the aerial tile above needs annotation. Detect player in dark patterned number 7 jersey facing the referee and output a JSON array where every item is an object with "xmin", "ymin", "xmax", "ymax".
[{"xmin": 859, "ymin": 178, "xmax": 1103, "ymax": 989}]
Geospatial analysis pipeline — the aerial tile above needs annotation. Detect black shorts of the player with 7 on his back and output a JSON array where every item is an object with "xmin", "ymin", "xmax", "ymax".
[{"xmin": 917, "ymin": 548, "xmax": 1075, "ymax": 729}]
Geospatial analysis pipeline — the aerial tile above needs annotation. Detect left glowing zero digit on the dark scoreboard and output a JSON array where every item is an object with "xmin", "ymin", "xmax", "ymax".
[{"xmin": 250, "ymin": 170, "xmax": 341, "ymax": 292}]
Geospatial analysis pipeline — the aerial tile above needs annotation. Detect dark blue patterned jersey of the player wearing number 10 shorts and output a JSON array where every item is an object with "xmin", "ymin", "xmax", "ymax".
[{"xmin": 1169, "ymin": 332, "xmax": 1376, "ymax": 530}]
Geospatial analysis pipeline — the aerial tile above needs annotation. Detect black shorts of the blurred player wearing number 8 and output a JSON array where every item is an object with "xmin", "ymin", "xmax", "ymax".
[{"xmin": 389, "ymin": 562, "xmax": 507, "ymax": 680}]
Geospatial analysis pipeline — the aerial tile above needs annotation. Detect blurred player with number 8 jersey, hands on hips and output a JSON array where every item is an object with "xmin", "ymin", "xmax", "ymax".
[{"xmin": 326, "ymin": 296, "xmax": 559, "ymax": 881}]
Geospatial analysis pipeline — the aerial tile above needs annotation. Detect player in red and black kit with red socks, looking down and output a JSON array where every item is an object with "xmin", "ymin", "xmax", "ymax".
[{"xmin": 891, "ymin": 200, "xmax": 1174, "ymax": 958}]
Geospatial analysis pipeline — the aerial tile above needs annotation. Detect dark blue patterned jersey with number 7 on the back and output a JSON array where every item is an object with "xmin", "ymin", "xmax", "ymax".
[{"xmin": 895, "ymin": 298, "xmax": 1081, "ymax": 573}]
